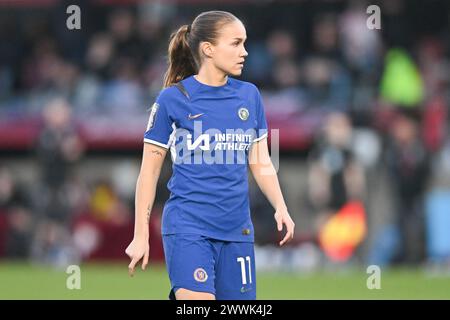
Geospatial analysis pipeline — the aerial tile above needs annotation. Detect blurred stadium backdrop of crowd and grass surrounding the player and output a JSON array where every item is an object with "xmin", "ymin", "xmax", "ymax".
[{"xmin": 0, "ymin": 0, "xmax": 450, "ymax": 299}]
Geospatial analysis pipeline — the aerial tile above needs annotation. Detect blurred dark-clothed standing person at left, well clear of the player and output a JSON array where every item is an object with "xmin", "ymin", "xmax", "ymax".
[{"xmin": 33, "ymin": 98, "xmax": 83, "ymax": 265}]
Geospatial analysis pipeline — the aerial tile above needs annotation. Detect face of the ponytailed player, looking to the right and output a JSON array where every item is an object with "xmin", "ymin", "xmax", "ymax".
[{"xmin": 213, "ymin": 21, "xmax": 248, "ymax": 76}]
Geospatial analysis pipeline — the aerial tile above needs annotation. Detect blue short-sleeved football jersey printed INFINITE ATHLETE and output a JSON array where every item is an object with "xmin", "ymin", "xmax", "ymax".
[{"xmin": 144, "ymin": 76, "xmax": 267, "ymax": 242}]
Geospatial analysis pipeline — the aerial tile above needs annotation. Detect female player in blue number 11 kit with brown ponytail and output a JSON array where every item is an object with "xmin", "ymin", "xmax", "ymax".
[{"xmin": 125, "ymin": 11, "xmax": 294, "ymax": 300}]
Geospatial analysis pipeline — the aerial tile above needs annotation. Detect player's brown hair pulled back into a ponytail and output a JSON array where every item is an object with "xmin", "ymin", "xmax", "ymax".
[{"xmin": 164, "ymin": 11, "xmax": 238, "ymax": 88}]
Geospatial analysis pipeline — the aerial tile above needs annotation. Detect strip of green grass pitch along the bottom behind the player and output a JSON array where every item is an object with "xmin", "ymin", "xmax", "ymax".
[{"xmin": 0, "ymin": 262, "xmax": 450, "ymax": 300}]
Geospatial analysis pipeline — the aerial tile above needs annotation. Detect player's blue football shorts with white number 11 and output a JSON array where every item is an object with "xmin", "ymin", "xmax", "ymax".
[{"xmin": 163, "ymin": 234, "xmax": 256, "ymax": 300}]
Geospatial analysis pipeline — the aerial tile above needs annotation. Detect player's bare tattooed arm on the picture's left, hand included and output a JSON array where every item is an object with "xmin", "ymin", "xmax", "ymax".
[{"xmin": 125, "ymin": 143, "xmax": 167, "ymax": 276}]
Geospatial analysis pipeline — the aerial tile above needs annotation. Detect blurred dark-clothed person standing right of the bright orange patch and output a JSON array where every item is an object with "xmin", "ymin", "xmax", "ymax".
[{"xmin": 386, "ymin": 113, "xmax": 430, "ymax": 263}]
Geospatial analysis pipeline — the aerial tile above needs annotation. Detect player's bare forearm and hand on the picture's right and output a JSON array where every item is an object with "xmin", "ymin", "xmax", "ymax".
[{"xmin": 248, "ymin": 138, "xmax": 295, "ymax": 246}]
